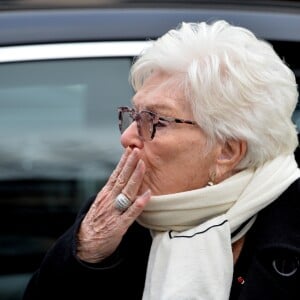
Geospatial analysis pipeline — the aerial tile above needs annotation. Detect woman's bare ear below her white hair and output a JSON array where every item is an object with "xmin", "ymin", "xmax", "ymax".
[{"xmin": 215, "ymin": 140, "xmax": 247, "ymax": 182}]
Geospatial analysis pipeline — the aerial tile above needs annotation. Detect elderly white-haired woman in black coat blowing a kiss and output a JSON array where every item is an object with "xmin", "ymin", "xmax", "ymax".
[{"xmin": 24, "ymin": 21, "xmax": 300, "ymax": 300}]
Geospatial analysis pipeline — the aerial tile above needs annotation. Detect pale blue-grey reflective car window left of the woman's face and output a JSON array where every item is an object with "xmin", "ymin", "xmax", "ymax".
[{"xmin": 0, "ymin": 58, "xmax": 132, "ymax": 180}]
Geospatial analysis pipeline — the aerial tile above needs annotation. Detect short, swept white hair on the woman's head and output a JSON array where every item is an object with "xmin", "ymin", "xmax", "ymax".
[{"xmin": 130, "ymin": 20, "xmax": 298, "ymax": 169}]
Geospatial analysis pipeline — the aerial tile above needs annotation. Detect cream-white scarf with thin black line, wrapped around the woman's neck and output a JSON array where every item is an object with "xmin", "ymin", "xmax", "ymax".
[{"xmin": 138, "ymin": 155, "xmax": 300, "ymax": 300}]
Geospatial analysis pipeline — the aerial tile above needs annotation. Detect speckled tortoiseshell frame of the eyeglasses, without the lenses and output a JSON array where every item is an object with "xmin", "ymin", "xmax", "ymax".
[{"xmin": 118, "ymin": 106, "xmax": 198, "ymax": 141}]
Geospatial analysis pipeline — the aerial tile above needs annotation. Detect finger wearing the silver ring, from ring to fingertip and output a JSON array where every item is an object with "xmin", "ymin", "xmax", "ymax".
[{"xmin": 122, "ymin": 159, "xmax": 146, "ymax": 202}]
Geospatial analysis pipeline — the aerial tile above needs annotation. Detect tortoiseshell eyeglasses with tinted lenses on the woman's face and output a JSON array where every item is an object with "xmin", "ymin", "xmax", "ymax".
[{"xmin": 118, "ymin": 106, "xmax": 197, "ymax": 141}]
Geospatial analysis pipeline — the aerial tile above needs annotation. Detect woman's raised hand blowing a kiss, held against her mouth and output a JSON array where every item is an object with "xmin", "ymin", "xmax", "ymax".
[{"xmin": 77, "ymin": 148, "xmax": 151, "ymax": 263}]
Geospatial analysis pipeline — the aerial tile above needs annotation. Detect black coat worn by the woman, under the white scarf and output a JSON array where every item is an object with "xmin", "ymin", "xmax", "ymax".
[{"xmin": 24, "ymin": 180, "xmax": 300, "ymax": 300}]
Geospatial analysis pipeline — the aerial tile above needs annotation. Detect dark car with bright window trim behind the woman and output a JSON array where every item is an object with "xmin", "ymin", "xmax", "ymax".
[{"xmin": 0, "ymin": 0, "xmax": 300, "ymax": 300}]
